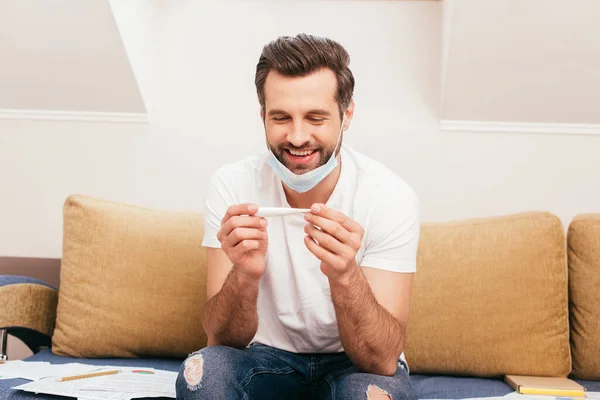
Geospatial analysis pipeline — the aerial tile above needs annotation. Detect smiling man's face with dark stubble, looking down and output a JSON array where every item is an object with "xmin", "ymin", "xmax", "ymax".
[{"xmin": 261, "ymin": 69, "xmax": 341, "ymax": 175}]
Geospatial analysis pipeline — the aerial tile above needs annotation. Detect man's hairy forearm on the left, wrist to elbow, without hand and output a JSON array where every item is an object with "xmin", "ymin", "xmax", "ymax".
[{"xmin": 203, "ymin": 267, "xmax": 258, "ymax": 348}]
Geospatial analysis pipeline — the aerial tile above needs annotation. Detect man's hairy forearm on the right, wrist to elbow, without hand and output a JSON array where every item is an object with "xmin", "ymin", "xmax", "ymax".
[{"xmin": 330, "ymin": 267, "xmax": 404, "ymax": 375}]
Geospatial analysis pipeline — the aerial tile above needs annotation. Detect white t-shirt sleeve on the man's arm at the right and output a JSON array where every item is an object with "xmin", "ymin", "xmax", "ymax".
[{"xmin": 360, "ymin": 192, "xmax": 420, "ymax": 273}]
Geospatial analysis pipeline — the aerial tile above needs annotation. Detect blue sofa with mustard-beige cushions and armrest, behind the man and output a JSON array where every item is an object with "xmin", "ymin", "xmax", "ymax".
[{"xmin": 0, "ymin": 195, "xmax": 600, "ymax": 399}]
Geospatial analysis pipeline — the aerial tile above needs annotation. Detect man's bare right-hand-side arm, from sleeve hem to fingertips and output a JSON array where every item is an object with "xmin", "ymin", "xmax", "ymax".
[{"xmin": 305, "ymin": 204, "xmax": 416, "ymax": 375}]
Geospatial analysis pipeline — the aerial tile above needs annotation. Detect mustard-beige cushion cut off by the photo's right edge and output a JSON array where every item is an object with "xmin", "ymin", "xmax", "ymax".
[{"xmin": 567, "ymin": 214, "xmax": 600, "ymax": 380}]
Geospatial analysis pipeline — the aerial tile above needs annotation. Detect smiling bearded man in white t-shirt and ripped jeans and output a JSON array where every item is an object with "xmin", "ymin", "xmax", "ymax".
[{"xmin": 177, "ymin": 34, "xmax": 419, "ymax": 399}]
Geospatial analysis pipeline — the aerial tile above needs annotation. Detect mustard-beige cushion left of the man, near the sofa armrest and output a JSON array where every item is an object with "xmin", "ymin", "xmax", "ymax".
[{"xmin": 52, "ymin": 196, "xmax": 206, "ymax": 357}]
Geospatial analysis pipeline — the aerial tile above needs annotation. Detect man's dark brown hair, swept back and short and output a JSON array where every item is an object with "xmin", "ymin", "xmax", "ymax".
[{"xmin": 254, "ymin": 33, "xmax": 354, "ymax": 118}]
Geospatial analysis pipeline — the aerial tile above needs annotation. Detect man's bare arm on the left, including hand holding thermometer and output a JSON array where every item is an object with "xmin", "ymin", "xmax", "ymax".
[{"xmin": 203, "ymin": 204, "xmax": 268, "ymax": 347}]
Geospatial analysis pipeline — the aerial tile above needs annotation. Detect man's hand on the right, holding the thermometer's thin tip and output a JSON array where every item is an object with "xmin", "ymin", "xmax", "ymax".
[{"xmin": 304, "ymin": 203, "xmax": 364, "ymax": 283}]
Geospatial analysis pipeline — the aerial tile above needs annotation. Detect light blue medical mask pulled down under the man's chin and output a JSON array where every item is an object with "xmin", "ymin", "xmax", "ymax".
[{"xmin": 267, "ymin": 117, "xmax": 345, "ymax": 193}]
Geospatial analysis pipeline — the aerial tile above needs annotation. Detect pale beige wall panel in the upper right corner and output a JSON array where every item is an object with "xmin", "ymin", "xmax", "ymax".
[{"xmin": 442, "ymin": 0, "xmax": 600, "ymax": 124}]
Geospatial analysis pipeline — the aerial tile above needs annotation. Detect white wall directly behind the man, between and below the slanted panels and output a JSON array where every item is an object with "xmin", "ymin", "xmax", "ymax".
[{"xmin": 0, "ymin": 0, "xmax": 600, "ymax": 257}]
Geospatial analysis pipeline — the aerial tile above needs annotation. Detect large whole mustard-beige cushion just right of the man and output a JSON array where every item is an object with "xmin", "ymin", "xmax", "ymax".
[{"xmin": 406, "ymin": 213, "xmax": 571, "ymax": 377}]
